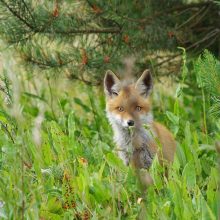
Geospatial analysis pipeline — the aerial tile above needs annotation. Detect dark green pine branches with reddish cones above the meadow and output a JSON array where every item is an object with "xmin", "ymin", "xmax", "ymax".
[{"xmin": 0, "ymin": 0, "xmax": 220, "ymax": 84}]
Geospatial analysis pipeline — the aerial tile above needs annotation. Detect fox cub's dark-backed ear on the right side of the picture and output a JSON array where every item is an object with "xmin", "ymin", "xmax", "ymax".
[{"xmin": 135, "ymin": 69, "xmax": 153, "ymax": 97}]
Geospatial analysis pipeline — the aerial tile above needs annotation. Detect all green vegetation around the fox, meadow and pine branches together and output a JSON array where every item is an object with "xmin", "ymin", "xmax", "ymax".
[{"xmin": 0, "ymin": 0, "xmax": 220, "ymax": 220}]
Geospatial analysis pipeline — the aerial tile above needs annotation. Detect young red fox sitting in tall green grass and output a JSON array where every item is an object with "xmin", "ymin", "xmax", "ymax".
[{"xmin": 104, "ymin": 70, "xmax": 176, "ymax": 169}]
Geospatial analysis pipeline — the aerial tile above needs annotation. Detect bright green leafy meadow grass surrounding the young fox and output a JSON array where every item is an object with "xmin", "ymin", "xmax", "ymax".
[{"xmin": 0, "ymin": 50, "xmax": 220, "ymax": 220}]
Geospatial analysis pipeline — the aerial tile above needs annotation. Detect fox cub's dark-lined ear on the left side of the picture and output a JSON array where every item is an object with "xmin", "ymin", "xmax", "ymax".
[{"xmin": 104, "ymin": 70, "xmax": 120, "ymax": 96}]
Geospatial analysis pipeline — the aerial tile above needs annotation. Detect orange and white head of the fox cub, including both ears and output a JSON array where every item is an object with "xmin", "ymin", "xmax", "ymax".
[{"xmin": 104, "ymin": 70, "xmax": 153, "ymax": 128}]
